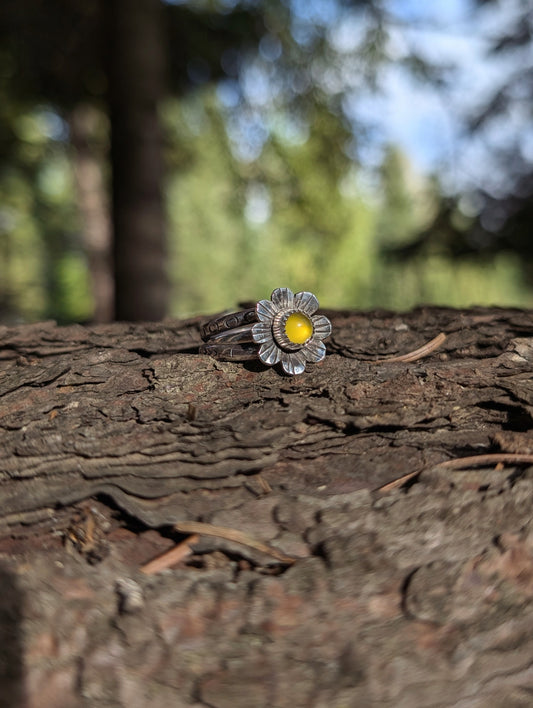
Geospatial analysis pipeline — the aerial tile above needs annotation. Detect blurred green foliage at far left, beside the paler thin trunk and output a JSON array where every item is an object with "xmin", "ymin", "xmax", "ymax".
[{"xmin": 0, "ymin": 108, "xmax": 92, "ymax": 321}]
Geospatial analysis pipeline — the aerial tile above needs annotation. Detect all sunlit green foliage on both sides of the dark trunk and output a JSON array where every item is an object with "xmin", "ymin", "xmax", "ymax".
[{"xmin": 0, "ymin": 92, "xmax": 533, "ymax": 321}]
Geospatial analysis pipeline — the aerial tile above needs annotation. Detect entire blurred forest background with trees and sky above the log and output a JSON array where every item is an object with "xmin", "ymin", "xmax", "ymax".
[{"xmin": 0, "ymin": 0, "xmax": 533, "ymax": 322}]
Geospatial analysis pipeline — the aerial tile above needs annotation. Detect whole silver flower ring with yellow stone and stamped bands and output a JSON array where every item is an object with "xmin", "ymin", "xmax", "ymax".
[{"xmin": 200, "ymin": 288, "xmax": 331, "ymax": 376}]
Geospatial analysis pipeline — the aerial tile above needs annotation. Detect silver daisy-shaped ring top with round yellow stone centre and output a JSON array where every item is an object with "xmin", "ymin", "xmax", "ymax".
[{"xmin": 252, "ymin": 288, "xmax": 331, "ymax": 375}]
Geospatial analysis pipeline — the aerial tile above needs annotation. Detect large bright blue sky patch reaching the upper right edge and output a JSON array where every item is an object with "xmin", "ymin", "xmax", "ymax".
[{"xmin": 363, "ymin": 0, "xmax": 533, "ymax": 194}]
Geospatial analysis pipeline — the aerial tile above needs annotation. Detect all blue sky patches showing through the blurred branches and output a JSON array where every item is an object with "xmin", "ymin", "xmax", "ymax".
[{"xmin": 212, "ymin": 0, "xmax": 533, "ymax": 198}]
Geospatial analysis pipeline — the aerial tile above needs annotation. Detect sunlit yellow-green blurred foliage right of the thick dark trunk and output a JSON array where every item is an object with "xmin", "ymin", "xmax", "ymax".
[{"xmin": 166, "ymin": 88, "xmax": 532, "ymax": 316}]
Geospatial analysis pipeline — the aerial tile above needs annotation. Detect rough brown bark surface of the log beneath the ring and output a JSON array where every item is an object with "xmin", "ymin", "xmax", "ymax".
[{"xmin": 0, "ymin": 308, "xmax": 533, "ymax": 708}]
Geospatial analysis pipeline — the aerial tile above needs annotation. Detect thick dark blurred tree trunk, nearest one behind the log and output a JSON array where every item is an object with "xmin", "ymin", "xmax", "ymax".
[{"xmin": 106, "ymin": 0, "xmax": 169, "ymax": 321}]
